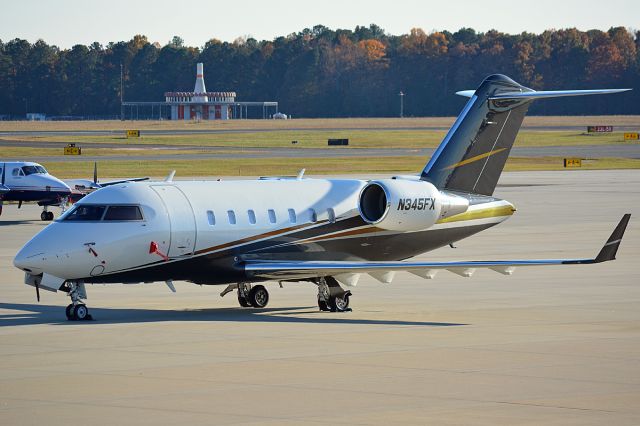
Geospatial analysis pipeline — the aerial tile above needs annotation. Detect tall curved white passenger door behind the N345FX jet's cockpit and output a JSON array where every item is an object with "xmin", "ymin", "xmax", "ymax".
[{"xmin": 152, "ymin": 185, "xmax": 197, "ymax": 257}]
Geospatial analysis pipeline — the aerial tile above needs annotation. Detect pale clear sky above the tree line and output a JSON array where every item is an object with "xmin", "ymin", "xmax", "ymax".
[{"xmin": 0, "ymin": 0, "xmax": 640, "ymax": 48}]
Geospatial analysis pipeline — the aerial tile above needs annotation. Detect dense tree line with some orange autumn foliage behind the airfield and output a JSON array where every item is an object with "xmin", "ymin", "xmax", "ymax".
[{"xmin": 0, "ymin": 24, "xmax": 640, "ymax": 117}]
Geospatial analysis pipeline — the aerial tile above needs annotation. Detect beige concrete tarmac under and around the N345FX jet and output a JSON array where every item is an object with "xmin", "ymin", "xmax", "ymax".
[{"xmin": 0, "ymin": 170, "xmax": 640, "ymax": 425}]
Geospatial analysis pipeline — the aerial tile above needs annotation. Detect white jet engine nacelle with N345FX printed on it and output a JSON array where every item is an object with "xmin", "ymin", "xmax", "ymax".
[{"xmin": 358, "ymin": 179, "xmax": 469, "ymax": 231}]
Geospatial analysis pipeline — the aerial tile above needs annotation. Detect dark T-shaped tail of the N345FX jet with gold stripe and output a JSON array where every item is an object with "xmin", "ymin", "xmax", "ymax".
[{"xmin": 420, "ymin": 74, "xmax": 631, "ymax": 195}]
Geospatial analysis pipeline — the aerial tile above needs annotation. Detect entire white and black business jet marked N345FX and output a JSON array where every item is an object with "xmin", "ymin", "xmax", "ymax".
[{"xmin": 14, "ymin": 74, "xmax": 630, "ymax": 320}]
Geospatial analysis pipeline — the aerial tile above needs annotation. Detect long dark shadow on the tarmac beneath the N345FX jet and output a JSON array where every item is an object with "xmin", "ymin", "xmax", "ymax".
[{"xmin": 0, "ymin": 303, "xmax": 467, "ymax": 327}]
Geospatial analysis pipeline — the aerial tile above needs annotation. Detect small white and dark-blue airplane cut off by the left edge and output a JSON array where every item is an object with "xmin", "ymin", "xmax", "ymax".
[{"xmin": 0, "ymin": 161, "xmax": 148, "ymax": 220}]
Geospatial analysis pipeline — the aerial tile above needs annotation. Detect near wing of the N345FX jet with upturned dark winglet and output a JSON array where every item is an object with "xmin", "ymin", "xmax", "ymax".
[{"xmin": 244, "ymin": 214, "xmax": 631, "ymax": 285}]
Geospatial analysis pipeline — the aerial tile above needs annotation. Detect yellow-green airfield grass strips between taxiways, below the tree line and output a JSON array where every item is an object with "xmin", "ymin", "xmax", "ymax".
[{"xmin": 0, "ymin": 116, "xmax": 640, "ymax": 178}]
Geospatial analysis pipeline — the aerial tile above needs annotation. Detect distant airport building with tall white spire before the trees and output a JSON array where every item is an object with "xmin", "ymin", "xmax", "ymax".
[{"xmin": 122, "ymin": 63, "xmax": 278, "ymax": 121}]
